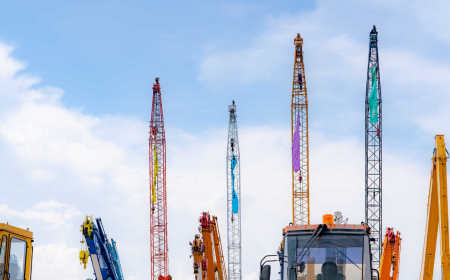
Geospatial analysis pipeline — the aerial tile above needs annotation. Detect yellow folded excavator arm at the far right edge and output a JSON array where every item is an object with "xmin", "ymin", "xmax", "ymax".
[{"xmin": 420, "ymin": 135, "xmax": 450, "ymax": 280}]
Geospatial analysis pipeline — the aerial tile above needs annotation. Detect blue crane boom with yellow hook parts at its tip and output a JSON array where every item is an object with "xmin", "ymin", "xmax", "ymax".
[{"xmin": 80, "ymin": 216, "xmax": 124, "ymax": 280}]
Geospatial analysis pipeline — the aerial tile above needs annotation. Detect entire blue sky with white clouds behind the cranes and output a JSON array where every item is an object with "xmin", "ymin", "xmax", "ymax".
[{"xmin": 0, "ymin": 0, "xmax": 450, "ymax": 280}]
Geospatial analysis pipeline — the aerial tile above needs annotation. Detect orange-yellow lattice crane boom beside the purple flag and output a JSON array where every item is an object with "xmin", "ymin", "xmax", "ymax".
[{"xmin": 291, "ymin": 33, "xmax": 309, "ymax": 225}]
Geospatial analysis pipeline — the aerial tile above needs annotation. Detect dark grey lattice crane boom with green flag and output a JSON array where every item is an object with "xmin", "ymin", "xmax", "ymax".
[{"xmin": 365, "ymin": 25, "xmax": 383, "ymax": 269}]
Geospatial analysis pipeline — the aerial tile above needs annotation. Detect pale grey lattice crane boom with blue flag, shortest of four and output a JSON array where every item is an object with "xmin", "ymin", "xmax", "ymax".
[{"xmin": 227, "ymin": 101, "xmax": 242, "ymax": 280}]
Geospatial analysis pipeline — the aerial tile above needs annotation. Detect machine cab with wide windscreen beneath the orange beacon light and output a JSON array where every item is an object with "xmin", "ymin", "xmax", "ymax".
[{"xmin": 279, "ymin": 224, "xmax": 372, "ymax": 280}]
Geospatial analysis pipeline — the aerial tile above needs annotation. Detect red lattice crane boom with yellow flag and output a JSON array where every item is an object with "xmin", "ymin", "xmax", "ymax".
[{"xmin": 149, "ymin": 78, "xmax": 168, "ymax": 280}]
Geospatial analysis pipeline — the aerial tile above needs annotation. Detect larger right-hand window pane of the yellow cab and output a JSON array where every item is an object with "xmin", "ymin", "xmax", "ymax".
[{"xmin": 8, "ymin": 237, "xmax": 27, "ymax": 280}]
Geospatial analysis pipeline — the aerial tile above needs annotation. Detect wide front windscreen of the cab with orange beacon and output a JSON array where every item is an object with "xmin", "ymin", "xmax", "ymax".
[{"xmin": 287, "ymin": 234, "xmax": 365, "ymax": 280}]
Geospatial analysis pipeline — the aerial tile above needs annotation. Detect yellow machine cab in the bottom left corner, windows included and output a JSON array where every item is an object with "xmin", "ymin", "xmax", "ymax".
[{"xmin": 0, "ymin": 223, "xmax": 33, "ymax": 280}]
